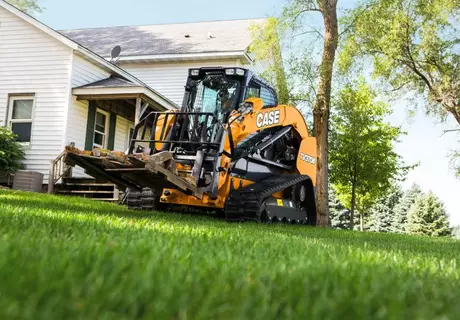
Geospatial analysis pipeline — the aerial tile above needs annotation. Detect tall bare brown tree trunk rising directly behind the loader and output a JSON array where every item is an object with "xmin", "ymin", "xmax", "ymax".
[{"xmin": 313, "ymin": 0, "xmax": 339, "ymax": 227}]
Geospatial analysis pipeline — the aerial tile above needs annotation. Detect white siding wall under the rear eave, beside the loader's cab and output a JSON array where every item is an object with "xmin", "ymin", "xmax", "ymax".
[{"xmin": 121, "ymin": 60, "xmax": 237, "ymax": 106}]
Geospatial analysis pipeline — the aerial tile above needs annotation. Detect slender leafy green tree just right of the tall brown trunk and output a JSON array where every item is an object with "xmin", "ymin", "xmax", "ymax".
[{"xmin": 330, "ymin": 79, "xmax": 402, "ymax": 230}]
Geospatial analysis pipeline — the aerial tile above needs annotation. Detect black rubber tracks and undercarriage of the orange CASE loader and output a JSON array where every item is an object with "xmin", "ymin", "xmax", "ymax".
[{"xmin": 126, "ymin": 174, "xmax": 316, "ymax": 225}]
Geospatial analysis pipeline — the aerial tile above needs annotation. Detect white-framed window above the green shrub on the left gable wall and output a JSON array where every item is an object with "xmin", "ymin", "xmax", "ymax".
[{"xmin": 8, "ymin": 96, "xmax": 34, "ymax": 144}]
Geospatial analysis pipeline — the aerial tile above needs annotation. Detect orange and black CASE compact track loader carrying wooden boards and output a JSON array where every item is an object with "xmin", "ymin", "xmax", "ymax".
[{"xmin": 65, "ymin": 67, "xmax": 317, "ymax": 225}]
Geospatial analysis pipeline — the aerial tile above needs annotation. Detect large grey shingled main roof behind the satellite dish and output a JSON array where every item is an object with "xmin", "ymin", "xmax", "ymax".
[{"xmin": 60, "ymin": 19, "xmax": 265, "ymax": 57}]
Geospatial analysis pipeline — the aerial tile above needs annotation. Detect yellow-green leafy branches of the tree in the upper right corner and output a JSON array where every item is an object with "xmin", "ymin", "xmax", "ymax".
[{"xmin": 339, "ymin": 0, "xmax": 460, "ymax": 124}]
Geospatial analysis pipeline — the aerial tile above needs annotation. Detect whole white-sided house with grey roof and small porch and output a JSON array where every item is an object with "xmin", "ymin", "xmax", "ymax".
[{"xmin": 0, "ymin": 0, "xmax": 274, "ymax": 194}]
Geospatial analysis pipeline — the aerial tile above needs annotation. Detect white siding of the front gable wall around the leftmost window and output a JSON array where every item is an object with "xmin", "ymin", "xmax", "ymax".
[{"xmin": 0, "ymin": 8, "xmax": 72, "ymax": 183}]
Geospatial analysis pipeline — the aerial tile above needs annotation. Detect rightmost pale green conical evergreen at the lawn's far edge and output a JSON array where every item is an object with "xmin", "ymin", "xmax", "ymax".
[{"xmin": 407, "ymin": 191, "xmax": 452, "ymax": 237}]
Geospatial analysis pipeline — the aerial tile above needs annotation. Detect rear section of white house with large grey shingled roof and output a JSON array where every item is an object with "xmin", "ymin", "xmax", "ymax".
[{"xmin": 61, "ymin": 19, "xmax": 265, "ymax": 105}]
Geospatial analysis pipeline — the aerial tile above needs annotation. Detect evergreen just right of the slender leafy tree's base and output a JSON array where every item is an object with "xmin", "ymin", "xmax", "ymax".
[{"xmin": 369, "ymin": 183, "xmax": 403, "ymax": 232}]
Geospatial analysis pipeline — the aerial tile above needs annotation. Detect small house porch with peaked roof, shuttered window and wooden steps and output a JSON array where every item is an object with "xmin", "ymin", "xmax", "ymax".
[{"xmin": 48, "ymin": 77, "xmax": 176, "ymax": 201}]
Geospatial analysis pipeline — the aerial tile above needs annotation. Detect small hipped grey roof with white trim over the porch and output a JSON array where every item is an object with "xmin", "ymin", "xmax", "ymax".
[{"xmin": 72, "ymin": 76, "xmax": 177, "ymax": 111}]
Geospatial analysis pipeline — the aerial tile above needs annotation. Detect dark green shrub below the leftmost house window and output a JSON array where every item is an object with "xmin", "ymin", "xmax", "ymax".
[{"xmin": 0, "ymin": 127, "xmax": 24, "ymax": 173}]
